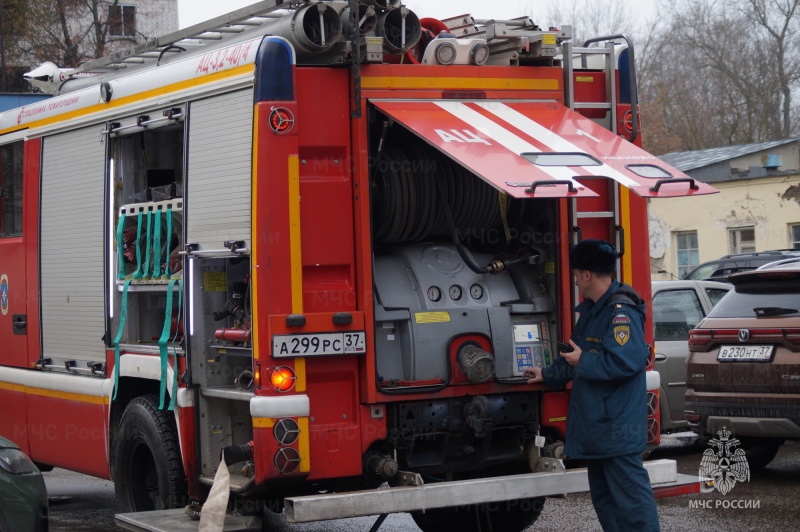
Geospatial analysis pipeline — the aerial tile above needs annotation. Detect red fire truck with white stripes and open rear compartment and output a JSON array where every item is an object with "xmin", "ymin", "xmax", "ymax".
[{"xmin": 0, "ymin": 0, "xmax": 714, "ymax": 531}]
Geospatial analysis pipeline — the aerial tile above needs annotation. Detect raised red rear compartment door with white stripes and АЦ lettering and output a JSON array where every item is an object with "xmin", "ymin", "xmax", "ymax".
[{"xmin": 372, "ymin": 100, "xmax": 717, "ymax": 198}]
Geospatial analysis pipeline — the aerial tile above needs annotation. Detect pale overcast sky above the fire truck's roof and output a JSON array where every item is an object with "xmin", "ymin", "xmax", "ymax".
[{"xmin": 178, "ymin": 0, "xmax": 657, "ymax": 28}]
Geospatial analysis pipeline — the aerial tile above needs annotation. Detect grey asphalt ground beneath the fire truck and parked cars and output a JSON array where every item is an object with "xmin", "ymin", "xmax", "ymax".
[{"xmin": 44, "ymin": 434, "xmax": 800, "ymax": 532}]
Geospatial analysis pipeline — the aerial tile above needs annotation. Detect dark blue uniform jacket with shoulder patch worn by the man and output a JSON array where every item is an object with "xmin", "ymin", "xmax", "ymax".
[{"xmin": 542, "ymin": 280, "xmax": 650, "ymax": 459}]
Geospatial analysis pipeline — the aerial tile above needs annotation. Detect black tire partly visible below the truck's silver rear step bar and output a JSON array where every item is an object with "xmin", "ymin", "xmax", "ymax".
[{"xmin": 411, "ymin": 497, "xmax": 544, "ymax": 532}]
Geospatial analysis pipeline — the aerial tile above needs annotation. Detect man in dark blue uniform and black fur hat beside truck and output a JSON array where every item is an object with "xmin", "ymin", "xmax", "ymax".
[{"xmin": 525, "ymin": 239, "xmax": 660, "ymax": 532}]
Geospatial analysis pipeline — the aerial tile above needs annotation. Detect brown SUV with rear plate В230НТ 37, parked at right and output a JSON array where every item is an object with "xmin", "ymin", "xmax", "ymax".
[{"xmin": 684, "ymin": 261, "xmax": 800, "ymax": 470}]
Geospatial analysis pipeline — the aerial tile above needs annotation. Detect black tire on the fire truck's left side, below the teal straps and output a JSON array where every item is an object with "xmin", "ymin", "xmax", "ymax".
[{"xmin": 113, "ymin": 395, "xmax": 187, "ymax": 513}]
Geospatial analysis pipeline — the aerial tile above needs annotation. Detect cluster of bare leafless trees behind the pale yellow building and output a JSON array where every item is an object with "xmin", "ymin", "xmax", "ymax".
[{"xmin": 528, "ymin": 0, "xmax": 800, "ymax": 153}]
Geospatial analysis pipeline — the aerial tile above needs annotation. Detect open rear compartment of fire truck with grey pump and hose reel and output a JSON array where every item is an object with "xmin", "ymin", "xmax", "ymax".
[{"xmin": 371, "ymin": 119, "xmax": 556, "ymax": 393}]
